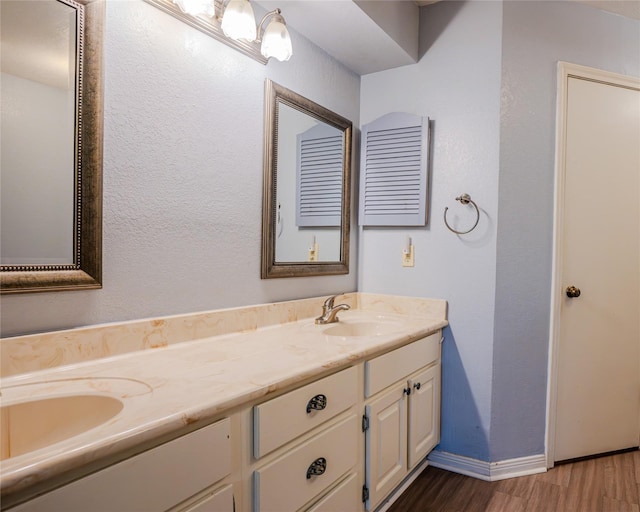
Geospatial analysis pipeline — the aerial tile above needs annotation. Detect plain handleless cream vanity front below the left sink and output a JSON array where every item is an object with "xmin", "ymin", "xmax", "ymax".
[{"xmin": 11, "ymin": 418, "xmax": 234, "ymax": 512}]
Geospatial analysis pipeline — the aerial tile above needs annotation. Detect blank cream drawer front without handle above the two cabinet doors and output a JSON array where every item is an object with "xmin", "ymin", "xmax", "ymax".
[{"xmin": 364, "ymin": 331, "xmax": 441, "ymax": 398}]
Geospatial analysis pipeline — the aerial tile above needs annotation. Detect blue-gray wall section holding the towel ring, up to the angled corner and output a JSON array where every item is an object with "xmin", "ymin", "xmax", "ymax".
[{"xmin": 359, "ymin": 2, "xmax": 502, "ymax": 459}]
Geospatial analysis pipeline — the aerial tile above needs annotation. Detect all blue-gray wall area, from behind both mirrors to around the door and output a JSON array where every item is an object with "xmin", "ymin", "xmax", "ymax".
[{"xmin": 1, "ymin": 0, "xmax": 640, "ymax": 461}]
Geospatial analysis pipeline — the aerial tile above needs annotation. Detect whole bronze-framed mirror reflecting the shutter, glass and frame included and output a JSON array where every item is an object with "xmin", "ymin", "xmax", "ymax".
[{"xmin": 262, "ymin": 80, "xmax": 352, "ymax": 279}]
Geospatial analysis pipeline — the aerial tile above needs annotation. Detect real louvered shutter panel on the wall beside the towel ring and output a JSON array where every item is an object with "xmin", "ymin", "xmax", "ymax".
[{"xmin": 359, "ymin": 112, "xmax": 429, "ymax": 226}]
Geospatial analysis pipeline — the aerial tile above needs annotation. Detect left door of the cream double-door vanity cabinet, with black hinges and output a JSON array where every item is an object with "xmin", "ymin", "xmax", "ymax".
[{"xmin": 365, "ymin": 386, "xmax": 407, "ymax": 510}]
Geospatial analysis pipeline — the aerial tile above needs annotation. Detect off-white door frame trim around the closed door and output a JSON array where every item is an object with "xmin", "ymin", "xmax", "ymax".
[{"xmin": 545, "ymin": 62, "xmax": 640, "ymax": 468}]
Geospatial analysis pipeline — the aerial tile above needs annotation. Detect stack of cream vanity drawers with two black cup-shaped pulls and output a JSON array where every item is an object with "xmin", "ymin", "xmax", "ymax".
[{"xmin": 252, "ymin": 367, "xmax": 362, "ymax": 512}]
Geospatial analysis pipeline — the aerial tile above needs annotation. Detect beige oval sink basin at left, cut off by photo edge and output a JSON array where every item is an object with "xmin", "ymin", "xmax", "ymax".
[{"xmin": 0, "ymin": 395, "xmax": 124, "ymax": 460}]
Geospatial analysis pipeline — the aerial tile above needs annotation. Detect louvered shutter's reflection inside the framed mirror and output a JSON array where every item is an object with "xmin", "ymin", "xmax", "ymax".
[{"xmin": 296, "ymin": 123, "xmax": 344, "ymax": 227}]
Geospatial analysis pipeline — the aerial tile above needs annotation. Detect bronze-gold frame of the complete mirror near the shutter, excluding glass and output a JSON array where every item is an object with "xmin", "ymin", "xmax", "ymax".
[{"xmin": 261, "ymin": 79, "xmax": 352, "ymax": 279}]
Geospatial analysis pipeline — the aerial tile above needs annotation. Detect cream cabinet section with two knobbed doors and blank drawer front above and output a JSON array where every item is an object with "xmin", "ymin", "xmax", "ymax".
[{"xmin": 363, "ymin": 332, "xmax": 441, "ymax": 510}]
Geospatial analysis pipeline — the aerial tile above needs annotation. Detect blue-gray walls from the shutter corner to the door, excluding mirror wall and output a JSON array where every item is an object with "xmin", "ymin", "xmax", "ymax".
[{"xmin": 359, "ymin": 1, "xmax": 640, "ymax": 462}]
